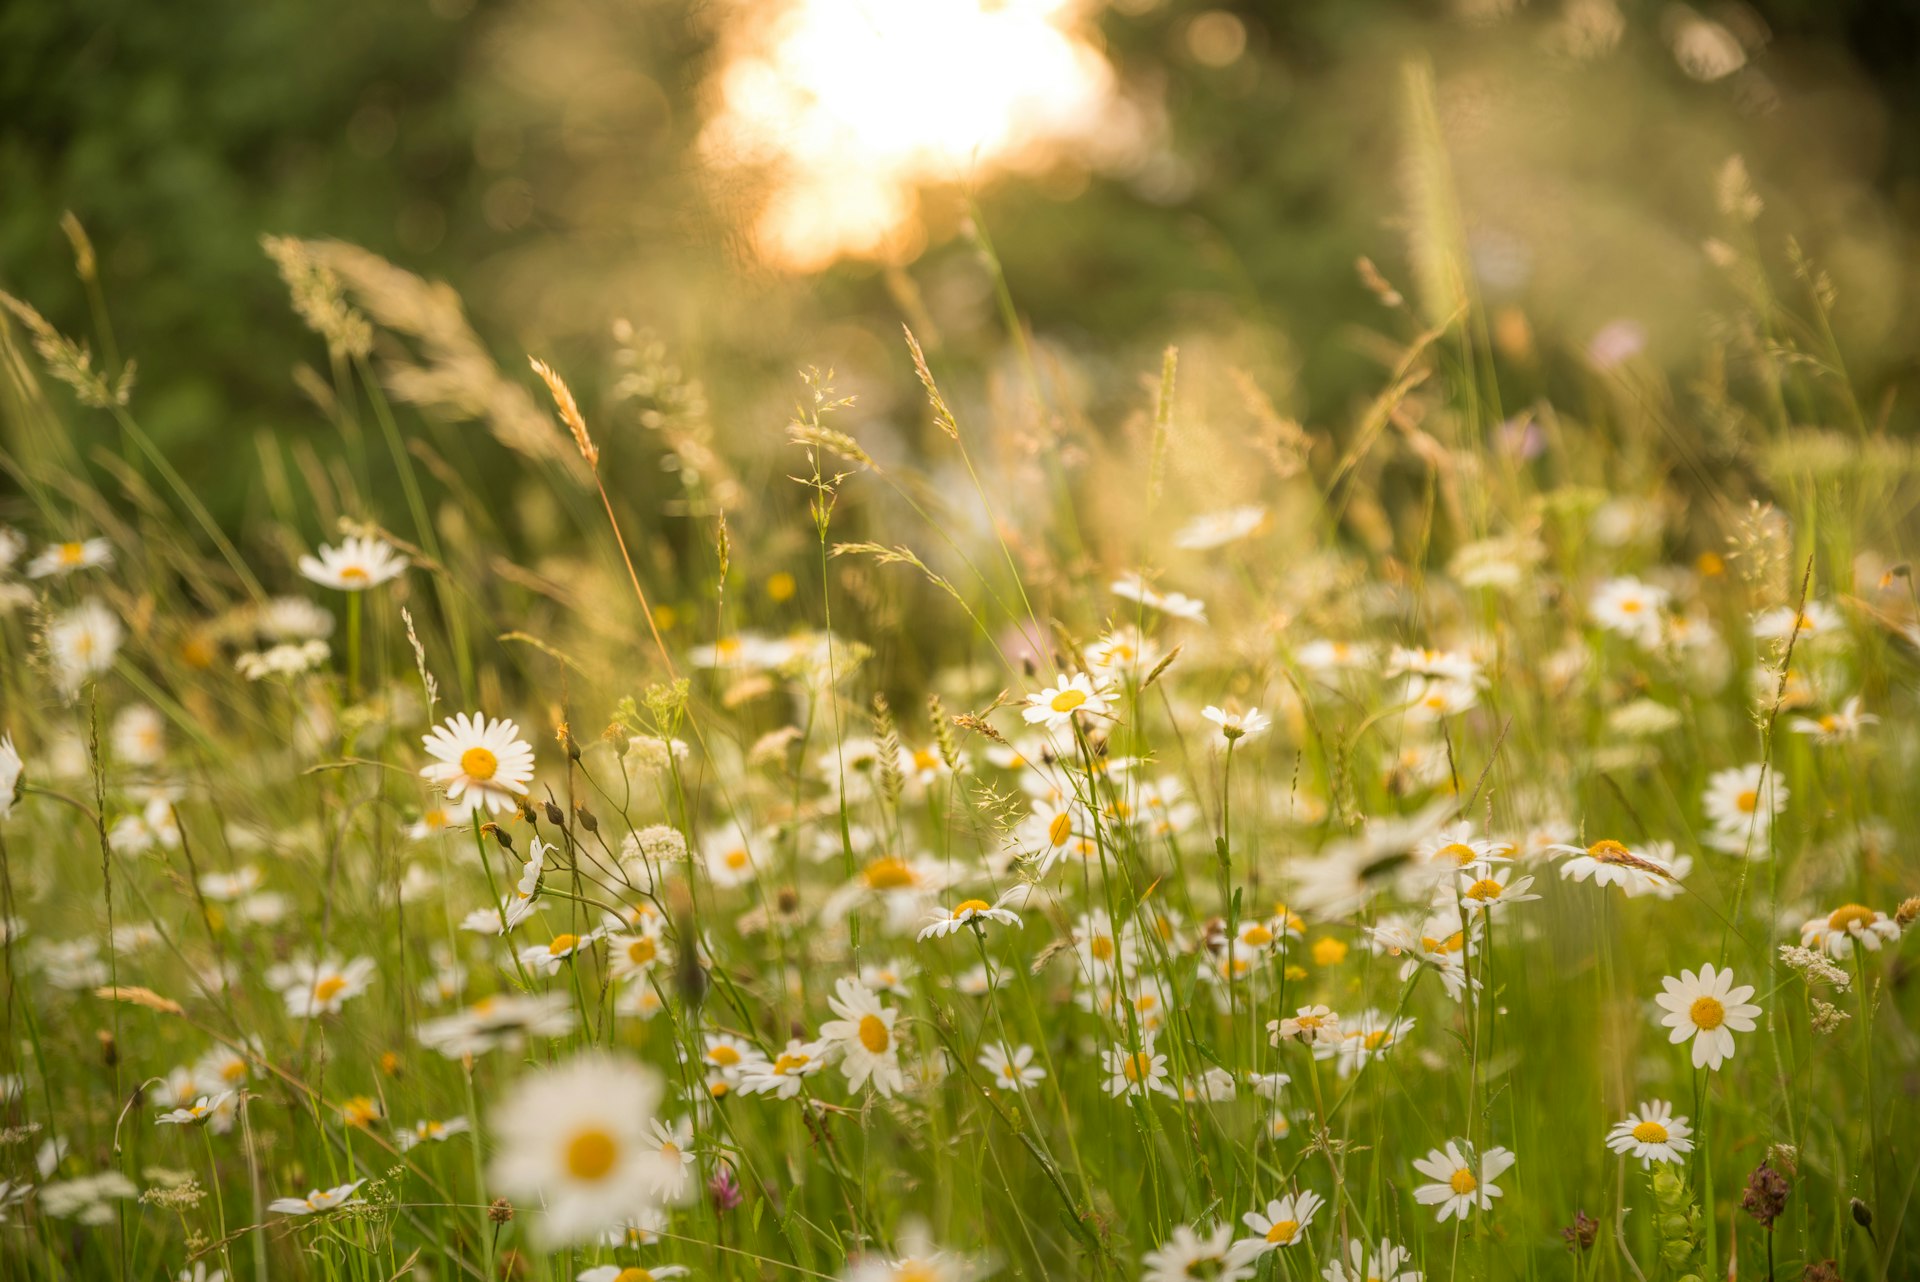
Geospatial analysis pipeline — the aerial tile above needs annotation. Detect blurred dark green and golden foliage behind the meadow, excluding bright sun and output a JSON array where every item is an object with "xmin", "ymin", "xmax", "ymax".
[{"xmin": 0, "ymin": 0, "xmax": 1920, "ymax": 528}]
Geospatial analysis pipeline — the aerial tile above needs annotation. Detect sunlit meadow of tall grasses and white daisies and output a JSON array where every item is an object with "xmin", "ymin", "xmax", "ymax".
[{"xmin": 0, "ymin": 82, "xmax": 1920, "ymax": 1282}]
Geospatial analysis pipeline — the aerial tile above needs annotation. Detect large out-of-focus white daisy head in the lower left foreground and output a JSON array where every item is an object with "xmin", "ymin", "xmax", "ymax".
[{"xmin": 490, "ymin": 1052, "xmax": 666, "ymax": 1246}]
